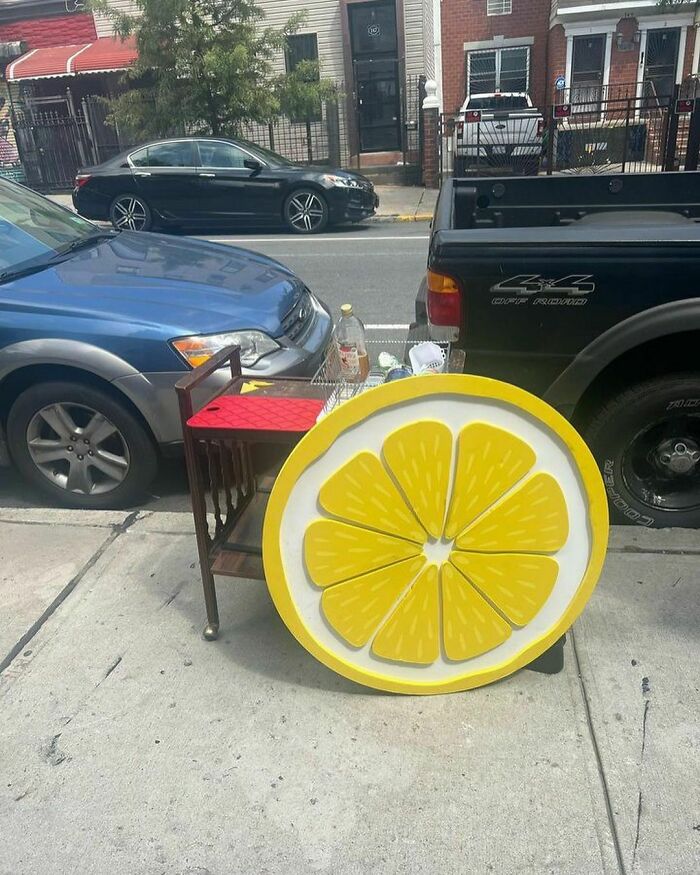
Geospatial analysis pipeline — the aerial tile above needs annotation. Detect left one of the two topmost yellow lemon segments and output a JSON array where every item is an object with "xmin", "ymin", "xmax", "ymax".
[{"xmin": 382, "ymin": 420, "xmax": 452, "ymax": 538}]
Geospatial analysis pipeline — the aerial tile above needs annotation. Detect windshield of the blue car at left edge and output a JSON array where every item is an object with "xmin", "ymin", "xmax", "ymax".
[{"xmin": 0, "ymin": 181, "xmax": 98, "ymax": 275}]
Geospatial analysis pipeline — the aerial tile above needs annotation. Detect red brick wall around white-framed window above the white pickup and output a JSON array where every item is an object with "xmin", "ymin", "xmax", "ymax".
[{"xmin": 442, "ymin": 0, "xmax": 550, "ymax": 113}]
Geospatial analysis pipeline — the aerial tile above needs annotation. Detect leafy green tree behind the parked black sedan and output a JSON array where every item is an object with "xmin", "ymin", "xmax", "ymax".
[{"xmin": 91, "ymin": 0, "xmax": 329, "ymax": 136}]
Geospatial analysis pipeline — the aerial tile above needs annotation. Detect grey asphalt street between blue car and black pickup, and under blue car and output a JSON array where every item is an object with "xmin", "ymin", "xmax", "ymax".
[{"xmin": 0, "ymin": 222, "xmax": 430, "ymax": 511}]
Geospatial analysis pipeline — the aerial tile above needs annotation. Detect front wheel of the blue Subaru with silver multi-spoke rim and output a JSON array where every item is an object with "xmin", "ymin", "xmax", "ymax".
[{"xmin": 7, "ymin": 381, "xmax": 158, "ymax": 510}]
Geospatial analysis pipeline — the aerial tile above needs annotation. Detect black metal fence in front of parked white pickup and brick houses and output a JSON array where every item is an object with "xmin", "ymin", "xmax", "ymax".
[{"xmin": 438, "ymin": 80, "xmax": 700, "ymax": 178}]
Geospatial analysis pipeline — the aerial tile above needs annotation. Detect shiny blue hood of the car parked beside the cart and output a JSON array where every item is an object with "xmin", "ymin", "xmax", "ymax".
[{"xmin": 0, "ymin": 231, "xmax": 305, "ymax": 340}]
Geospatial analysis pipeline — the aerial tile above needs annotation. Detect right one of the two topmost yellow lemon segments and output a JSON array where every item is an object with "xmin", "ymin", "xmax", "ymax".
[{"xmin": 445, "ymin": 422, "xmax": 536, "ymax": 538}]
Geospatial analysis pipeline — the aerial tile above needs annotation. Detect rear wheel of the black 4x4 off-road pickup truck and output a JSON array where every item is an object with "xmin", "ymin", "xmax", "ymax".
[{"xmin": 584, "ymin": 373, "xmax": 700, "ymax": 528}]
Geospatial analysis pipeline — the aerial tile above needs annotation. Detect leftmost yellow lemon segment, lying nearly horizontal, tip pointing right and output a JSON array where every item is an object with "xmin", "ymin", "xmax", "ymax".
[{"xmin": 304, "ymin": 519, "xmax": 422, "ymax": 587}]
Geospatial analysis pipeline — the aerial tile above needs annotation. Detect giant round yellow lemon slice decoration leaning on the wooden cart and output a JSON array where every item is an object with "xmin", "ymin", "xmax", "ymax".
[{"xmin": 263, "ymin": 375, "xmax": 608, "ymax": 693}]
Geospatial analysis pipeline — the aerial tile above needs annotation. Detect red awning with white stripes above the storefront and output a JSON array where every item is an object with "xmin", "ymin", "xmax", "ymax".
[{"xmin": 6, "ymin": 37, "xmax": 138, "ymax": 82}]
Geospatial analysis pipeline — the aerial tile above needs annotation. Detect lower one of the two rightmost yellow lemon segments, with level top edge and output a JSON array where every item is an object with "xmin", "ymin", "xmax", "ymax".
[{"xmin": 450, "ymin": 551, "xmax": 559, "ymax": 626}]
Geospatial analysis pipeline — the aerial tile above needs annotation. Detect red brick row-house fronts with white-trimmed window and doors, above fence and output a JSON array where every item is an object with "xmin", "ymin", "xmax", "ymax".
[{"xmin": 441, "ymin": 0, "xmax": 700, "ymax": 114}]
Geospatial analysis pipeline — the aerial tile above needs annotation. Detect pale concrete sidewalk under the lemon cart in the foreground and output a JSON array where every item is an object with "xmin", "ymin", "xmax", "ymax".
[{"xmin": 0, "ymin": 509, "xmax": 700, "ymax": 875}]
